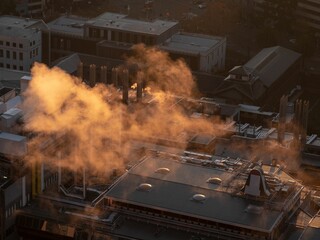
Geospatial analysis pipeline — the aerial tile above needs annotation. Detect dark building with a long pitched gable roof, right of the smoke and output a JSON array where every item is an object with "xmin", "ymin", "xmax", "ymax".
[{"xmin": 213, "ymin": 46, "xmax": 301, "ymax": 111}]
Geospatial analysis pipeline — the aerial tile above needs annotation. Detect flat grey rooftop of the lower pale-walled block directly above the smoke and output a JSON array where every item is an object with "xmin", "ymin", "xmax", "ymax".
[{"xmin": 161, "ymin": 33, "xmax": 223, "ymax": 54}]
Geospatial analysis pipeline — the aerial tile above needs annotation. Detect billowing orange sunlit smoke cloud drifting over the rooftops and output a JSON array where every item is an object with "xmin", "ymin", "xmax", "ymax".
[{"xmin": 23, "ymin": 45, "xmax": 224, "ymax": 176}]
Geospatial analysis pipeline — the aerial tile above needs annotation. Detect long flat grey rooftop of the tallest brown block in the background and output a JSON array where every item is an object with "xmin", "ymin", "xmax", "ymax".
[{"xmin": 86, "ymin": 12, "xmax": 179, "ymax": 35}]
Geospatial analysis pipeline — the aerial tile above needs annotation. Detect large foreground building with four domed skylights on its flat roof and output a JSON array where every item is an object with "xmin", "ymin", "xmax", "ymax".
[{"xmin": 13, "ymin": 151, "xmax": 303, "ymax": 240}]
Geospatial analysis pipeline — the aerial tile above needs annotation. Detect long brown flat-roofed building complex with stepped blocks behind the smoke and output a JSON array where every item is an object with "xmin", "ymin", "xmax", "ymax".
[{"xmin": 44, "ymin": 12, "xmax": 226, "ymax": 73}]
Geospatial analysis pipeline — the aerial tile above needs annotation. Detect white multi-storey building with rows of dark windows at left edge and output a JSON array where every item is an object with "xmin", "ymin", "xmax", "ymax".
[{"xmin": 0, "ymin": 16, "xmax": 43, "ymax": 71}]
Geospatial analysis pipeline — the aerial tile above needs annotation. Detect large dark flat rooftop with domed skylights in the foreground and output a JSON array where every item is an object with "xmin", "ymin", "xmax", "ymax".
[{"xmin": 106, "ymin": 157, "xmax": 302, "ymax": 232}]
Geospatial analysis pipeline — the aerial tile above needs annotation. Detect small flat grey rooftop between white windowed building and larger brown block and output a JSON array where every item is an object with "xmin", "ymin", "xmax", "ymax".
[{"xmin": 48, "ymin": 16, "xmax": 88, "ymax": 37}]
